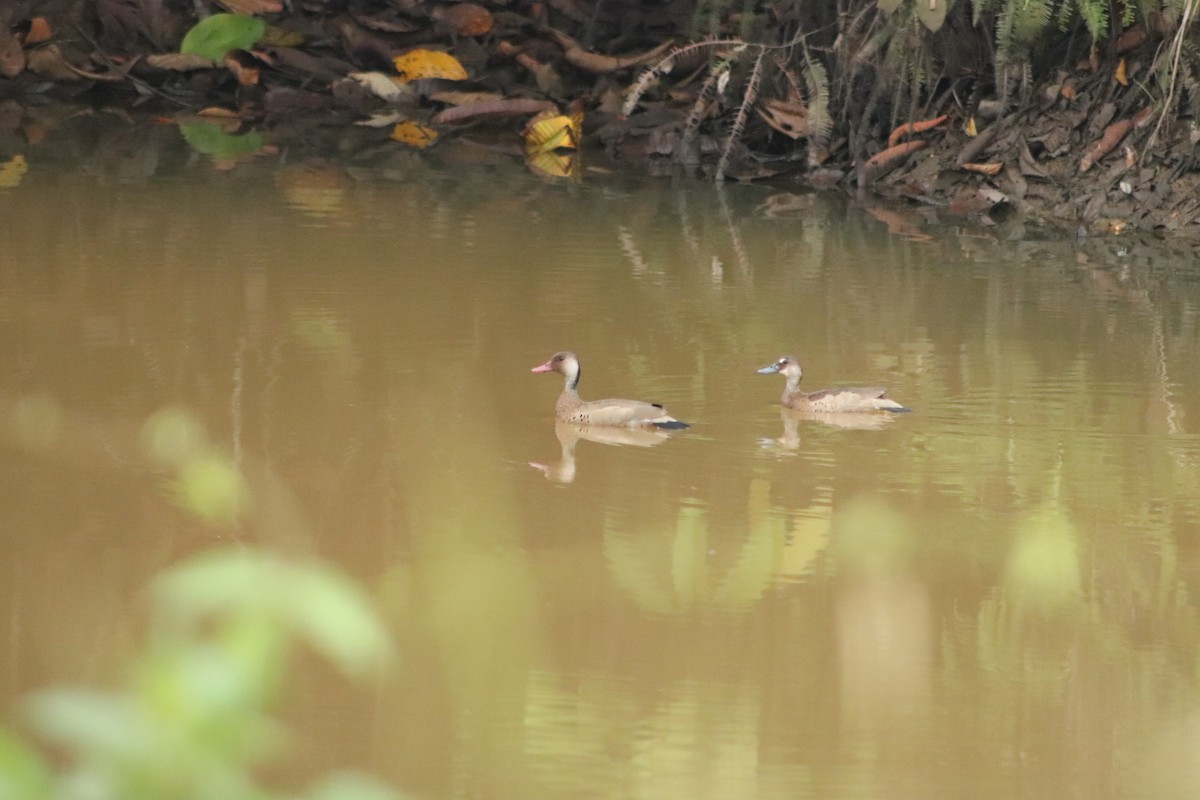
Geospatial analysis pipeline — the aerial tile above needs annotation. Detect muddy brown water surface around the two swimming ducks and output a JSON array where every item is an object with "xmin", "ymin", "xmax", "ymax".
[{"xmin": 0, "ymin": 145, "xmax": 1200, "ymax": 800}]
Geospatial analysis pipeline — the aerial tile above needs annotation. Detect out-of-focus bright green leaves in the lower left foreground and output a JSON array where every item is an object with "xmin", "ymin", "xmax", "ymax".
[{"xmin": 0, "ymin": 407, "xmax": 402, "ymax": 800}]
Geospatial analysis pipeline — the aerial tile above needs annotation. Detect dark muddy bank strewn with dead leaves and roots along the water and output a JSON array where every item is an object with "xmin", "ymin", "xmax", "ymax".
[{"xmin": 0, "ymin": 0, "xmax": 1200, "ymax": 236}]
